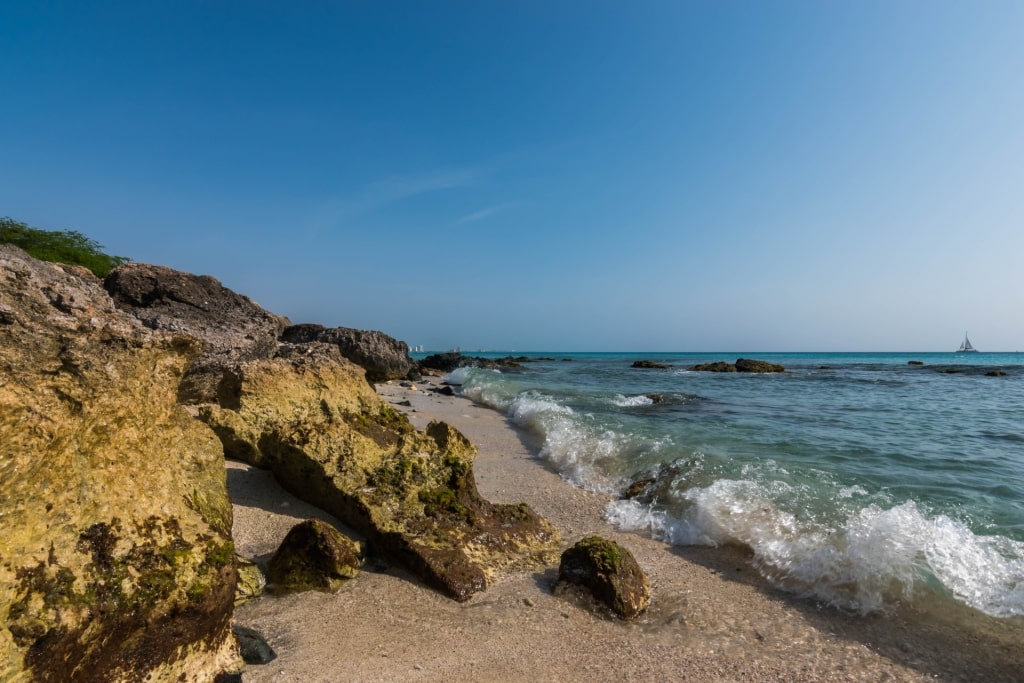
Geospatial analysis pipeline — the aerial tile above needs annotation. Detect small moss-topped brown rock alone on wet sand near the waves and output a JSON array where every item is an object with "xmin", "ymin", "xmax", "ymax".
[{"xmin": 555, "ymin": 536, "xmax": 650, "ymax": 620}]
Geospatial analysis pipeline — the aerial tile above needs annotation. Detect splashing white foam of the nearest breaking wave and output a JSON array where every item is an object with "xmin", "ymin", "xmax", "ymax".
[{"xmin": 605, "ymin": 479, "xmax": 1024, "ymax": 616}]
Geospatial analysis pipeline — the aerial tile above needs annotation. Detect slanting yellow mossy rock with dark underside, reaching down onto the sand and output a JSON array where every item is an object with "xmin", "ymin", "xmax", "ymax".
[{"xmin": 199, "ymin": 342, "xmax": 558, "ymax": 600}]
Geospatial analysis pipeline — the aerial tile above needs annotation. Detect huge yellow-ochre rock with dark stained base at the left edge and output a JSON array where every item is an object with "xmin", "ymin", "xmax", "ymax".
[{"xmin": 0, "ymin": 245, "xmax": 240, "ymax": 682}]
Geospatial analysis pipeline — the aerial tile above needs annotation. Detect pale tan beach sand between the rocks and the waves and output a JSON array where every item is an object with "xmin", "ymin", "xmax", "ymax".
[{"xmin": 228, "ymin": 376, "xmax": 1024, "ymax": 683}]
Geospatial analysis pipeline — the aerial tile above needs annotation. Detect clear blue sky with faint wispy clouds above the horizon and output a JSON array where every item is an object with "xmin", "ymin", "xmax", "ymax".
[{"xmin": 0, "ymin": 0, "xmax": 1024, "ymax": 351}]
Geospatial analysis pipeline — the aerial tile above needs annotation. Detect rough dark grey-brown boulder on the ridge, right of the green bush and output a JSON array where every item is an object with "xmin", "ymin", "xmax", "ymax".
[{"xmin": 103, "ymin": 263, "xmax": 289, "ymax": 403}]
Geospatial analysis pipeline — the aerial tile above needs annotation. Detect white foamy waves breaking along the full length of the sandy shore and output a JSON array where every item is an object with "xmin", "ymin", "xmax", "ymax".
[{"xmin": 450, "ymin": 362, "xmax": 1024, "ymax": 616}]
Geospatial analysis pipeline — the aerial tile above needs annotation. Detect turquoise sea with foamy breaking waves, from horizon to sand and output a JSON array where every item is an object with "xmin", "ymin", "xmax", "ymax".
[{"xmin": 430, "ymin": 353, "xmax": 1024, "ymax": 617}]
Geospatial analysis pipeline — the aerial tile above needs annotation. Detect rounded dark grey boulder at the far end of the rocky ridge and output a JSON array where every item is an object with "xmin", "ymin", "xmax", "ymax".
[{"xmin": 281, "ymin": 324, "xmax": 416, "ymax": 382}]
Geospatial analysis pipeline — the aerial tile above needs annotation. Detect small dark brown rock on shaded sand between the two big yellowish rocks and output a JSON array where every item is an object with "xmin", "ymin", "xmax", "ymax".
[{"xmin": 266, "ymin": 519, "xmax": 361, "ymax": 593}]
